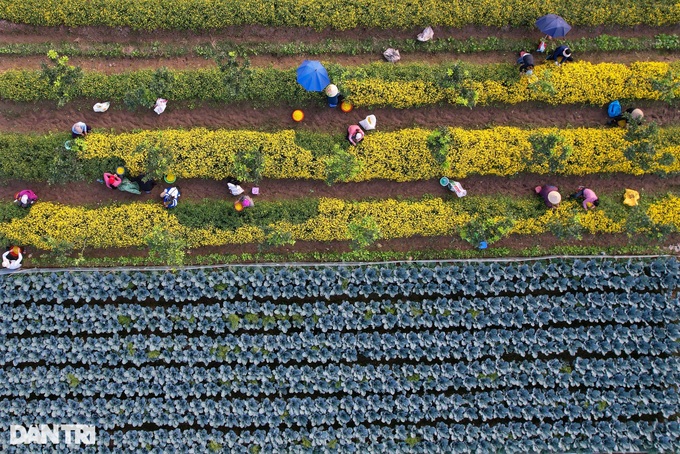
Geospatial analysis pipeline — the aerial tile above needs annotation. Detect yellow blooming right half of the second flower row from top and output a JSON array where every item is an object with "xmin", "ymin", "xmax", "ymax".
[{"xmin": 350, "ymin": 61, "xmax": 680, "ymax": 108}]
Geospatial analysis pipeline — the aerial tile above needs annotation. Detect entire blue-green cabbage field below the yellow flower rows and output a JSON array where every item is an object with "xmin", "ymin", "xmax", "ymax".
[{"xmin": 0, "ymin": 258, "xmax": 680, "ymax": 453}]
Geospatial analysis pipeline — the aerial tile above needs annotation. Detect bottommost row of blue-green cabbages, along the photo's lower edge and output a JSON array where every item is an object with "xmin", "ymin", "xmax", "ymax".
[{"xmin": 2, "ymin": 420, "xmax": 680, "ymax": 454}]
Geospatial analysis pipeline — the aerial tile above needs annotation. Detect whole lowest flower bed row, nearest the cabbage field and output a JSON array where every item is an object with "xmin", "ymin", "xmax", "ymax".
[{"xmin": 0, "ymin": 195, "xmax": 680, "ymax": 249}]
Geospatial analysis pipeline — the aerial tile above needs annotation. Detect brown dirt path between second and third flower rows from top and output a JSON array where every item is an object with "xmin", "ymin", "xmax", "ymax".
[{"xmin": 0, "ymin": 100, "xmax": 680, "ymax": 134}]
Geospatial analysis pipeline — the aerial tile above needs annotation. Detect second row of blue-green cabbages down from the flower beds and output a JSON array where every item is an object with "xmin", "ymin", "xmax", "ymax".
[{"xmin": 0, "ymin": 290, "xmax": 680, "ymax": 336}]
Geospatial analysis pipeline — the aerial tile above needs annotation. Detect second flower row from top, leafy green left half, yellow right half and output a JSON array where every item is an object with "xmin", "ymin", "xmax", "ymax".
[{"xmin": 0, "ymin": 62, "xmax": 680, "ymax": 108}]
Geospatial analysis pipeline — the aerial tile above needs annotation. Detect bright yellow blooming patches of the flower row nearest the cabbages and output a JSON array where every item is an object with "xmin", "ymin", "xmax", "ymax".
[{"xmin": 0, "ymin": 196, "xmax": 680, "ymax": 249}]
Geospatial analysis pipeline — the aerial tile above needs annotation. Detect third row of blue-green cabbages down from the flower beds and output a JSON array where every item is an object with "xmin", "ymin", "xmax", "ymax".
[{"xmin": 0, "ymin": 324, "xmax": 679, "ymax": 366}]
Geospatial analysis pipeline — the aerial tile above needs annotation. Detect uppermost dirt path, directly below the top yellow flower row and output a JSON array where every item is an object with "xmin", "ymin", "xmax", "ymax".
[{"xmin": 0, "ymin": 21, "xmax": 680, "ymax": 45}]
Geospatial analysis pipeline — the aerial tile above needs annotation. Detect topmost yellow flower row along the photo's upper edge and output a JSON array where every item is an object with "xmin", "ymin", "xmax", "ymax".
[{"xmin": 0, "ymin": 0, "xmax": 680, "ymax": 30}]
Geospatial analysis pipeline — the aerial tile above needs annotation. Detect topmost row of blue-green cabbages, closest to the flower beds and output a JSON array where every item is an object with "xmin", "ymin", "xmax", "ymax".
[{"xmin": 0, "ymin": 258, "xmax": 680, "ymax": 304}]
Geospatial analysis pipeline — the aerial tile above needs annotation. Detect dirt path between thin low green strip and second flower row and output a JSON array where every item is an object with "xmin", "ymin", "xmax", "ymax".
[{"xmin": 0, "ymin": 52, "xmax": 680, "ymax": 74}]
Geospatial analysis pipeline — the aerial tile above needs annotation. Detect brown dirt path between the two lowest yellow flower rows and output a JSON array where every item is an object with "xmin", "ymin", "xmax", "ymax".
[{"xmin": 0, "ymin": 174, "xmax": 680, "ymax": 206}]
